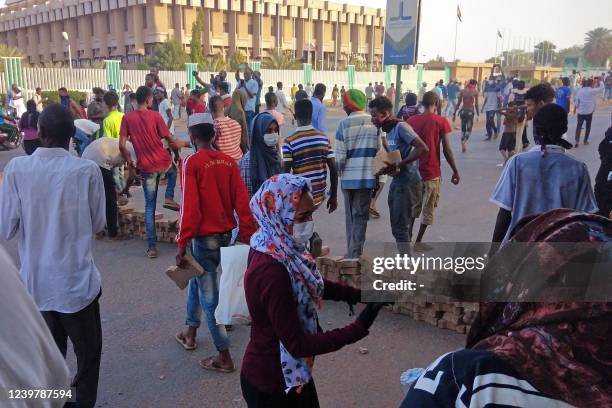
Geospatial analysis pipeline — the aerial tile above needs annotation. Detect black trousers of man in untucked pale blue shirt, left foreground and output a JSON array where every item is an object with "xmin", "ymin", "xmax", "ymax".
[{"xmin": 41, "ymin": 292, "xmax": 102, "ymax": 408}]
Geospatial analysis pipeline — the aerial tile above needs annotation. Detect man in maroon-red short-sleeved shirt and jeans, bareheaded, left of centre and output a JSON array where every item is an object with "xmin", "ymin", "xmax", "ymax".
[{"xmin": 119, "ymin": 86, "xmax": 178, "ymax": 258}]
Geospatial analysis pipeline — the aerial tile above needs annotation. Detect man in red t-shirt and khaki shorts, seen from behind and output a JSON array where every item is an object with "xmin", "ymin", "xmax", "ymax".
[{"xmin": 407, "ymin": 91, "xmax": 459, "ymax": 242}]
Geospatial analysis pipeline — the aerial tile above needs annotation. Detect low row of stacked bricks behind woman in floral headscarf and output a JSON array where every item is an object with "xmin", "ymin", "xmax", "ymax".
[{"xmin": 317, "ymin": 256, "xmax": 480, "ymax": 334}]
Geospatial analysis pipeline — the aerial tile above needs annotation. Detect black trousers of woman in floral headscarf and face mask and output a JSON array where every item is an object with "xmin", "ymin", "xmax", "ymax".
[{"xmin": 240, "ymin": 373, "xmax": 319, "ymax": 408}]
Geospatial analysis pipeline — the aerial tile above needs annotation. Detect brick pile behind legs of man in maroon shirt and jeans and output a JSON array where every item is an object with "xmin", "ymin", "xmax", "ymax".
[{"xmin": 119, "ymin": 206, "xmax": 178, "ymax": 243}]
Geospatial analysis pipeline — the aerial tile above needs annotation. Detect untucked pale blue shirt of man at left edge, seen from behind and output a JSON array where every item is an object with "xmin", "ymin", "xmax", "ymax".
[{"xmin": 0, "ymin": 147, "xmax": 106, "ymax": 313}]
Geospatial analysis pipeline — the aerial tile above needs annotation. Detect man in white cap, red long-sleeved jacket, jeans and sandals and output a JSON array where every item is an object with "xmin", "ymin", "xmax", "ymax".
[{"xmin": 176, "ymin": 113, "xmax": 255, "ymax": 372}]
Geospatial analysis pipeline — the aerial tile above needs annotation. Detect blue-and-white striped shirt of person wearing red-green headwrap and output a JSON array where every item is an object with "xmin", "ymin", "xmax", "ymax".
[{"xmin": 336, "ymin": 111, "xmax": 379, "ymax": 190}]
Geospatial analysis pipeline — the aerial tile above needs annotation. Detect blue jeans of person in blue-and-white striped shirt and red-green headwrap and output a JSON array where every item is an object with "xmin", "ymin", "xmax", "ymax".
[{"xmin": 342, "ymin": 188, "xmax": 372, "ymax": 258}]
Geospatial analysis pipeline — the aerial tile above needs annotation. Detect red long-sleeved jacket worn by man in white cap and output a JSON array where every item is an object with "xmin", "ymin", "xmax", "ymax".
[{"xmin": 176, "ymin": 150, "xmax": 255, "ymax": 248}]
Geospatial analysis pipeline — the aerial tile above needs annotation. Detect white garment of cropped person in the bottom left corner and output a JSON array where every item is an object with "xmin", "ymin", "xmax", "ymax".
[{"xmin": 0, "ymin": 246, "xmax": 74, "ymax": 408}]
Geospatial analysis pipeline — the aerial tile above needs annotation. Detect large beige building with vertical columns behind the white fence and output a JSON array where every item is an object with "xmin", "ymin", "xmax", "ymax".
[{"xmin": 0, "ymin": 0, "xmax": 385, "ymax": 69}]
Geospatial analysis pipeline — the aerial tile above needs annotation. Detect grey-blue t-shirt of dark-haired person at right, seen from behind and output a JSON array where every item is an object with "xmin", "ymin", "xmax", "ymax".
[{"xmin": 489, "ymin": 145, "xmax": 597, "ymax": 241}]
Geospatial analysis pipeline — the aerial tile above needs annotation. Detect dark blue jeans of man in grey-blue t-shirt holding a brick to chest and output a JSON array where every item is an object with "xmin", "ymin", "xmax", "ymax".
[{"xmin": 387, "ymin": 178, "xmax": 422, "ymax": 249}]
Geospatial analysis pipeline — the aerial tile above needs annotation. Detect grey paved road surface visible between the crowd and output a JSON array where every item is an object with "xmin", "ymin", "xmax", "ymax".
[{"xmin": 0, "ymin": 107, "xmax": 611, "ymax": 408}]
